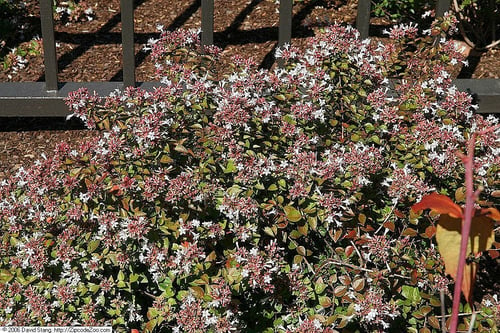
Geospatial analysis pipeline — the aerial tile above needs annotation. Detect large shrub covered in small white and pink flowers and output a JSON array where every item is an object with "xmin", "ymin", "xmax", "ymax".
[{"xmin": 0, "ymin": 18, "xmax": 500, "ymax": 332}]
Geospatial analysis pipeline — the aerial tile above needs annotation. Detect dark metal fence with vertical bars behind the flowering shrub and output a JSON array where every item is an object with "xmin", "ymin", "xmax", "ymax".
[{"xmin": 0, "ymin": 0, "xmax": 500, "ymax": 117}]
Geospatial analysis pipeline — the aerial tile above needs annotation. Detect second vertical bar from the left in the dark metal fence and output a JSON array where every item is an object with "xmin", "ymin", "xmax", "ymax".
[{"xmin": 120, "ymin": 0, "xmax": 135, "ymax": 88}]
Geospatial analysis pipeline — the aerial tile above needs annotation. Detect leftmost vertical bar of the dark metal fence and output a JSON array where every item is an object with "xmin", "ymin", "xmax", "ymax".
[{"xmin": 40, "ymin": 0, "xmax": 57, "ymax": 91}]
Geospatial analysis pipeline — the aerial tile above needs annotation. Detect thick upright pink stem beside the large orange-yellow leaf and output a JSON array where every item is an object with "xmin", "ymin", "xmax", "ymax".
[{"xmin": 450, "ymin": 133, "xmax": 476, "ymax": 333}]
